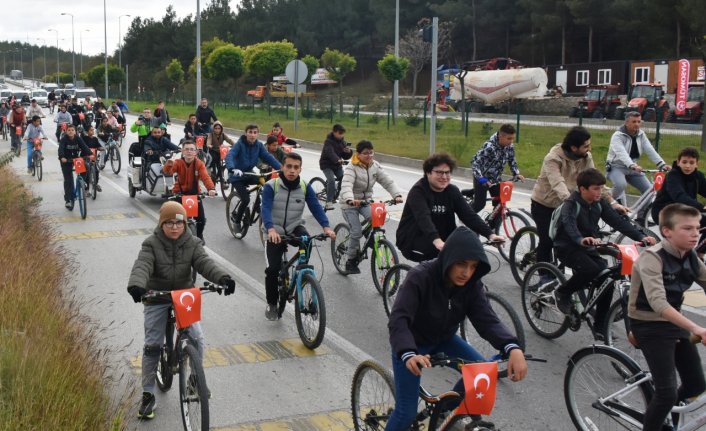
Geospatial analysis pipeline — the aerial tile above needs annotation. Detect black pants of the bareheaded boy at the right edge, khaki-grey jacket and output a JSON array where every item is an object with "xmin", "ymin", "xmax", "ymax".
[{"xmin": 631, "ymin": 319, "xmax": 706, "ymax": 431}]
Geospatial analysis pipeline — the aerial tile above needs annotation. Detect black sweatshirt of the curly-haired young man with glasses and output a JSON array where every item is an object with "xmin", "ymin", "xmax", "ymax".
[{"xmin": 397, "ymin": 176, "xmax": 493, "ymax": 252}]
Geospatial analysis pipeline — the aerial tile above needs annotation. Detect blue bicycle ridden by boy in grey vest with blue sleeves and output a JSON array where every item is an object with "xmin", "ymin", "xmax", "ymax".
[{"xmin": 277, "ymin": 233, "xmax": 328, "ymax": 350}]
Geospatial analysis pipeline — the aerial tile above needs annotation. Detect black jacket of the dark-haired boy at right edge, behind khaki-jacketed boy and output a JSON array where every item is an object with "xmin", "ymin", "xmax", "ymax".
[{"xmin": 652, "ymin": 162, "xmax": 706, "ymax": 220}]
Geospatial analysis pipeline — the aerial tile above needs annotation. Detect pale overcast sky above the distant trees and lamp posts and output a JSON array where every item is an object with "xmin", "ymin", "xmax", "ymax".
[{"xmin": 0, "ymin": 0, "xmax": 238, "ymax": 55}]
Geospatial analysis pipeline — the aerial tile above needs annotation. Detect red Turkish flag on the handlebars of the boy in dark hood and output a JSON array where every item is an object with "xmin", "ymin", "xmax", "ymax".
[{"xmin": 457, "ymin": 362, "xmax": 498, "ymax": 415}]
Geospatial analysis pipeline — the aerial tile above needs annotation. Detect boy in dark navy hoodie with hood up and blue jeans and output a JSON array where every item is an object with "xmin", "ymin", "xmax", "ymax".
[{"xmin": 385, "ymin": 226, "xmax": 527, "ymax": 431}]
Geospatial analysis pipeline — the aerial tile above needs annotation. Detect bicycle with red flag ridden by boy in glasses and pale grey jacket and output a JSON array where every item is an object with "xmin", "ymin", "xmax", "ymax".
[{"xmin": 331, "ymin": 199, "xmax": 400, "ymax": 295}]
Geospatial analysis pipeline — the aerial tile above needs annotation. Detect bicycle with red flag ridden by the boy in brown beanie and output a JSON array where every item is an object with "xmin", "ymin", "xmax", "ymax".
[{"xmin": 142, "ymin": 282, "xmax": 225, "ymax": 431}]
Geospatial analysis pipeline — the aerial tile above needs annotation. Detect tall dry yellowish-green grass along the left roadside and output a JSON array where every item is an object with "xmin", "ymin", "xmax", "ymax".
[{"xmin": 0, "ymin": 168, "xmax": 128, "ymax": 431}]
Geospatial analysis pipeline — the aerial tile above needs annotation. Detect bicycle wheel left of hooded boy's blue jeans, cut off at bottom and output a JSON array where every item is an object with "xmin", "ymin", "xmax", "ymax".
[{"xmin": 351, "ymin": 360, "xmax": 395, "ymax": 431}]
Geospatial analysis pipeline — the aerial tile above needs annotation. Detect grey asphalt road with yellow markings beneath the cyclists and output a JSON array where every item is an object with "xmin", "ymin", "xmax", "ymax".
[{"xmin": 8, "ymin": 98, "xmax": 704, "ymax": 430}]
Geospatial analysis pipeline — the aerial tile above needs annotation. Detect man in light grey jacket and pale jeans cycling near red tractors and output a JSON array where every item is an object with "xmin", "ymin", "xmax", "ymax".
[{"xmin": 606, "ymin": 111, "xmax": 671, "ymax": 203}]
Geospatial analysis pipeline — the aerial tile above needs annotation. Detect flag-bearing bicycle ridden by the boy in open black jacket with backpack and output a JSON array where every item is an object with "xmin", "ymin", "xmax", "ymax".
[{"xmin": 522, "ymin": 242, "xmax": 644, "ymax": 341}]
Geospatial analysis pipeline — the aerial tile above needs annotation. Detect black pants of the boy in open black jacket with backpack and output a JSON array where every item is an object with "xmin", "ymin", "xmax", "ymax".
[{"xmin": 557, "ymin": 248, "xmax": 613, "ymax": 332}]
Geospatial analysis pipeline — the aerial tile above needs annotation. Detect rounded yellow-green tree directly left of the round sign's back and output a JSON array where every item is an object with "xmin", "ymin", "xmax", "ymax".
[{"xmin": 244, "ymin": 40, "xmax": 297, "ymax": 82}]
